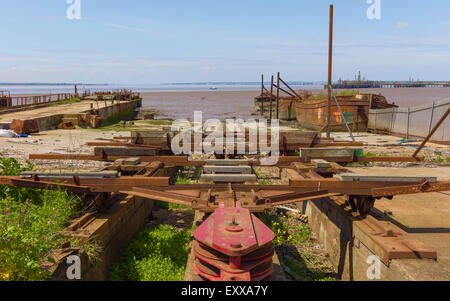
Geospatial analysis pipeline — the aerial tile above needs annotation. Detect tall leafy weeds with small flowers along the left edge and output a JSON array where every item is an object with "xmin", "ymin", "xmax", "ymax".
[{"xmin": 0, "ymin": 158, "xmax": 82, "ymax": 281}]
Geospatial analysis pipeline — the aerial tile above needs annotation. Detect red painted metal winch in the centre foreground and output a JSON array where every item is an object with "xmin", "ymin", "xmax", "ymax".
[{"xmin": 194, "ymin": 202, "xmax": 275, "ymax": 281}]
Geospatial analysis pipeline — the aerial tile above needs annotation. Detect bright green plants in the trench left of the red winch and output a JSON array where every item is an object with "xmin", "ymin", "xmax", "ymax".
[{"xmin": 109, "ymin": 225, "xmax": 192, "ymax": 281}]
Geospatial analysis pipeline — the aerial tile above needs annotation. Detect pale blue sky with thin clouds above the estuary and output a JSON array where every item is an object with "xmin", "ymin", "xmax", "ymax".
[{"xmin": 0, "ymin": 0, "xmax": 450, "ymax": 84}]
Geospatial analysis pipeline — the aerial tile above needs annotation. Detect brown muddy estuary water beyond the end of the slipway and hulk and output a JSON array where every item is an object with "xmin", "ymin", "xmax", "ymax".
[{"xmin": 141, "ymin": 88, "xmax": 450, "ymax": 120}]
